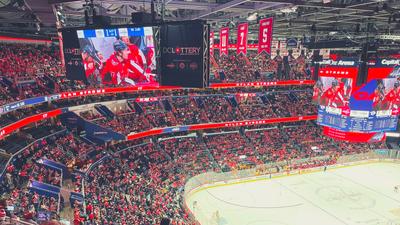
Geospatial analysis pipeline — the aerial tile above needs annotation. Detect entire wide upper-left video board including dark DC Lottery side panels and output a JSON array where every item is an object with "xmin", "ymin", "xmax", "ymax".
[{"xmin": 61, "ymin": 21, "xmax": 209, "ymax": 87}]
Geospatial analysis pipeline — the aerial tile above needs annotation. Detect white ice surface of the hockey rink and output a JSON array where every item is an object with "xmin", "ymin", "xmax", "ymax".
[{"xmin": 187, "ymin": 163, "xmax": 400, "ymax": 225}]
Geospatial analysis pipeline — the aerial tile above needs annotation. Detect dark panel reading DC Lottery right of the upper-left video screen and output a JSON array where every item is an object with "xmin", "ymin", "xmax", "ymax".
[{"xmin": 160, "ymin": 21, "xmax": 210, "ymax": 88}]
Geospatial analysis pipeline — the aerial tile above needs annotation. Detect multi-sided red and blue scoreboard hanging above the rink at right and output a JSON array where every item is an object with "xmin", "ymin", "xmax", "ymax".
[{"xmin": 313, "ymin": 59, "xmax": 400, "ymax": 136}]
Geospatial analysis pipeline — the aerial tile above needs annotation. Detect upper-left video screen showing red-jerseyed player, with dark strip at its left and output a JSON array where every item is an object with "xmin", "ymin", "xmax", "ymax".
[{"xmin": 62, "ymin": 27, "xmax": 158, "ymax": 86}]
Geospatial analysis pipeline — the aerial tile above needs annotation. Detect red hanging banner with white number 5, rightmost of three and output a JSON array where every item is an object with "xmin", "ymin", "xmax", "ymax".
[{"xmin": 258, "ymin": 17, "xmax": 274, "ymax": 54}]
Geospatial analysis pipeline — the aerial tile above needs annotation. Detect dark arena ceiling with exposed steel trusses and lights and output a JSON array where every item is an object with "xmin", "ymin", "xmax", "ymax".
[{"xmin": 0, "ymin": 0, "xmax": 400, "ymax": 40}]
